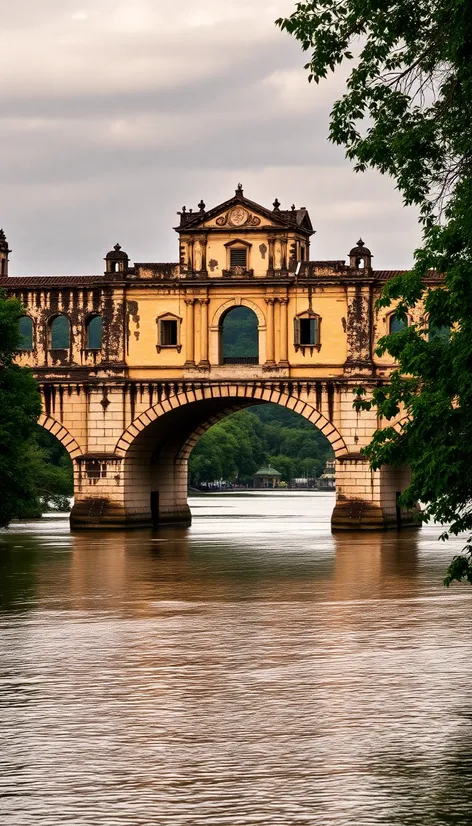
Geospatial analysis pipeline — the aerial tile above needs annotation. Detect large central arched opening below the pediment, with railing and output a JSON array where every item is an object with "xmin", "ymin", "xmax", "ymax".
[{"xmin": 220, "ymin": 307, "xmax": 259, "ymax": 364}]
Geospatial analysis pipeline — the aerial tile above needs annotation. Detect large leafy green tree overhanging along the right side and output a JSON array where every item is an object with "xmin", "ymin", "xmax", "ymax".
[{"xmin": 277, "ymin": 0, "xmax": 472, "ymax": 584}]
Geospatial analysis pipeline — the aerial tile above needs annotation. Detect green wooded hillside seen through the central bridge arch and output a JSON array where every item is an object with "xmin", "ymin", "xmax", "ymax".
[{"xmin": 189, "ymin": 405, "xmax": 332, "ymax": 485}]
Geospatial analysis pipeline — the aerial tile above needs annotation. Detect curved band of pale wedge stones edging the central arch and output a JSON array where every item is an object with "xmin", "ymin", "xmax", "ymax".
[{"xmin": 115, "ymin": 383, "xmax": 348, "ymax": 456}]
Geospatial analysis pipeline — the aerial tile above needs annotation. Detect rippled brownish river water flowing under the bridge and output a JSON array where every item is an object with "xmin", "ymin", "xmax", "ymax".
[{"xmin": 0, "ymin": 492, "xmax": 472, "ymax": 826}]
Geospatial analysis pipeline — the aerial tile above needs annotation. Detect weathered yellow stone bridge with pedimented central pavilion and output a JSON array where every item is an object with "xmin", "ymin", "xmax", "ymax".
[{"xmin": 0, "ymin": 186, "xmax": 436, "ymax": 530}]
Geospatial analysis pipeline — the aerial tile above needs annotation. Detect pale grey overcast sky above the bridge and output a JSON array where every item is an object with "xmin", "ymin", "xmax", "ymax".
[{"xmin": 0, "ymin": 0, "xmax": 419, "ymax": 275}]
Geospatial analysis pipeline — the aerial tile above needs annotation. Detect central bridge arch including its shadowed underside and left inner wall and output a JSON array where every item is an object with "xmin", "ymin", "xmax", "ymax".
[{"xmin": 108, "ymin": 382, "xmax": 347, "ymax": 525}]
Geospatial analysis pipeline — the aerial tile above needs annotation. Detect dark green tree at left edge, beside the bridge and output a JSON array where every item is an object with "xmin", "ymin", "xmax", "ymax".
[{"xmin": 0, "ymin": 292, "xmax": 41, "ymax": 527}]
